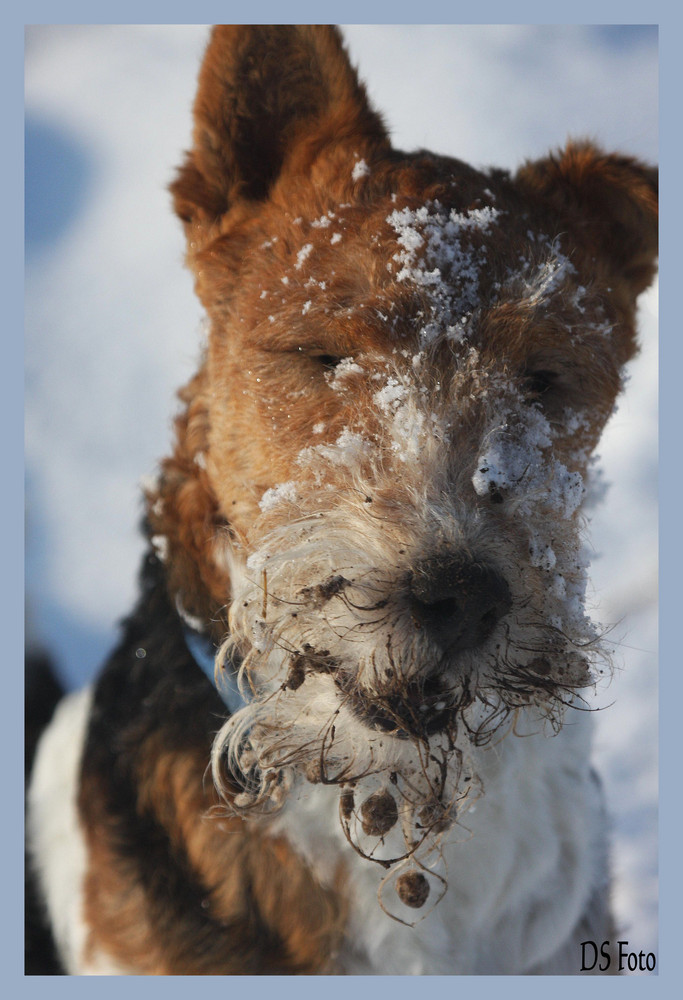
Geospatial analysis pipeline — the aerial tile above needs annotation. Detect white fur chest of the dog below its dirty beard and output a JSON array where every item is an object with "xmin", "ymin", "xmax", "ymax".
[{"xmin": 270, "ymin": 720, "xmax": 602, "ymax": 975}]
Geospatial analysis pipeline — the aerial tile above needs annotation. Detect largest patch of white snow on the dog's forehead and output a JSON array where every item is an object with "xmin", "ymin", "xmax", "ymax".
[{"xmin": 387, "ymin": 201, "xmax": 500, "ymax": 346}]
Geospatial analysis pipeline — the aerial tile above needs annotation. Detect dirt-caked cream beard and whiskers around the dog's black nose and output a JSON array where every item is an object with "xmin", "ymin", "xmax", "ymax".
[{"xmin": 213, "ymin": 484, "xmax": 594, "ymax": 905}]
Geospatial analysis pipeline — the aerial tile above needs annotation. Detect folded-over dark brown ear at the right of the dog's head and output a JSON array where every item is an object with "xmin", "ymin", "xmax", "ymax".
[{"xmin": 516, "ymin": 143, "xmax": 658, "ymax": 305}]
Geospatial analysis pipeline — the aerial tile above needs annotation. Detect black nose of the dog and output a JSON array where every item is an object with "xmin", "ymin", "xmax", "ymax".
[{"xmin": 410, "ymin": 555, "xmax": 512, "ymax": 652}]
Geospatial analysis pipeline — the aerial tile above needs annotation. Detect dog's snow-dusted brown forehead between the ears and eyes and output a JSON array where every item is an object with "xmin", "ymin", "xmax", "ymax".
[{"xmin": 228, "ymin": 154, "xmax": 588, "ymax": 355}]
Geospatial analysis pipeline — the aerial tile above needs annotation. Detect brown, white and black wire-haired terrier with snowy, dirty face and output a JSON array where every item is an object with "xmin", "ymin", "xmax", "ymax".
[{"xmin": 28, "ymin": 25, "xmax": 657, "ymax": 975}]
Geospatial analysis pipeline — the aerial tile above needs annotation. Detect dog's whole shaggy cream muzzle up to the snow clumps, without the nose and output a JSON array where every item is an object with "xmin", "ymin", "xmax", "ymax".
[{"xmin": 213, "ymin": 356, "xmax": 599, "ymax": 907}]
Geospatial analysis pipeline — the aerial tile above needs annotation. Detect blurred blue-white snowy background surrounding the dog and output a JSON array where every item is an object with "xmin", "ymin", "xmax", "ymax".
[{"xmin": 25, "ymin": 25, "xmax": 658, "ymax": 968}]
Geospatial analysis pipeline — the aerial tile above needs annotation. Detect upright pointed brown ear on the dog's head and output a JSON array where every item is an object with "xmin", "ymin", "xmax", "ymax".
[{"xmin": 171, "ymin": 25, "xmax": 388, "ymax": 226}]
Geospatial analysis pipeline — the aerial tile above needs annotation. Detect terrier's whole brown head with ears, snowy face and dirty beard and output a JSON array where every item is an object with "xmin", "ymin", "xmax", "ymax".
[{"xmin": 150, "ymin": 27, "xmax": 656, "ymax": 908}]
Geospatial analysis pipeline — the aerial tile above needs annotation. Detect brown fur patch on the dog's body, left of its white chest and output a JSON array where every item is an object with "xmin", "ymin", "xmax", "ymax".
[{"xmin": 81, "ymin": 739, "xmax": 344, "ymax": 975}]
